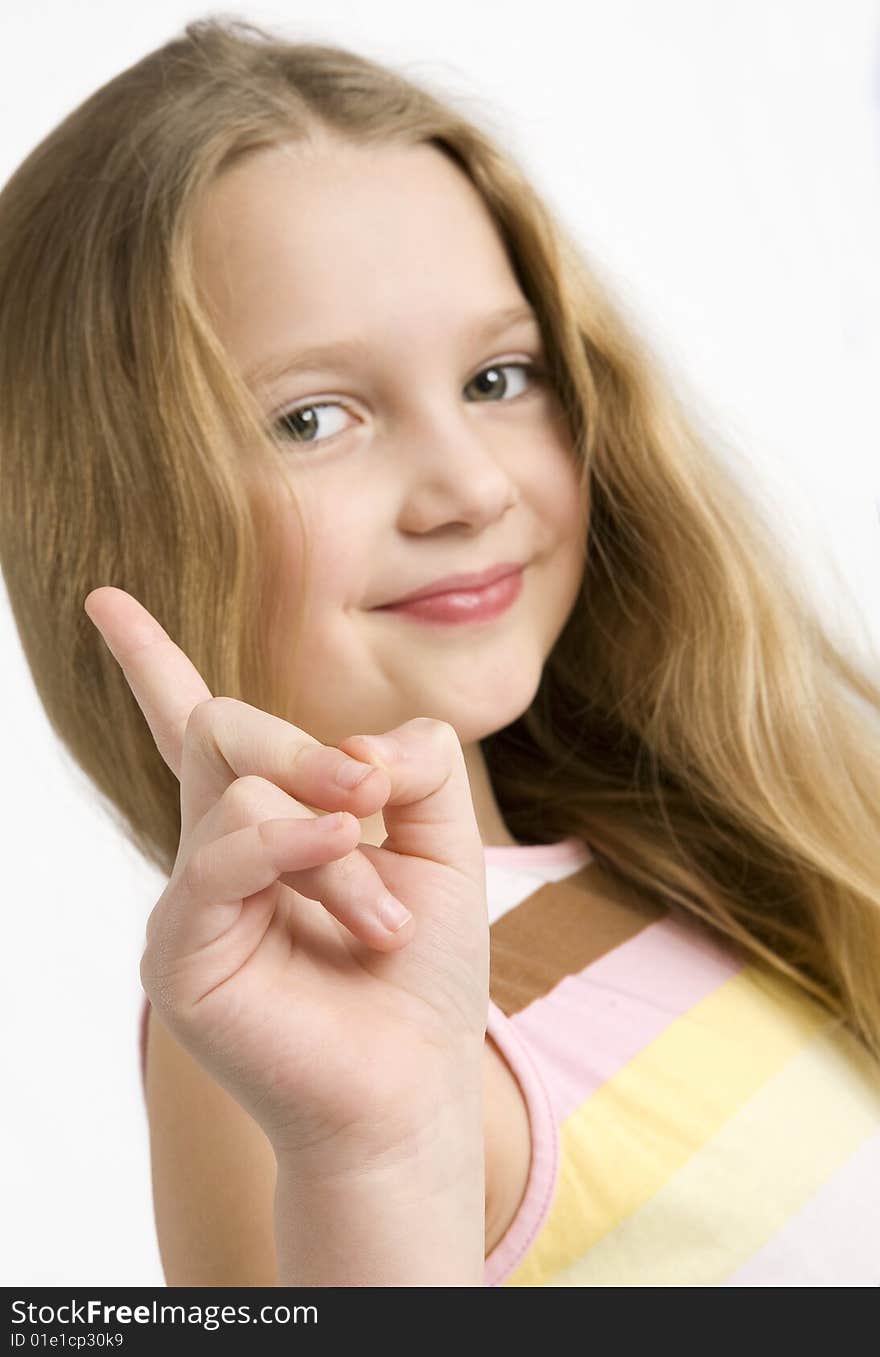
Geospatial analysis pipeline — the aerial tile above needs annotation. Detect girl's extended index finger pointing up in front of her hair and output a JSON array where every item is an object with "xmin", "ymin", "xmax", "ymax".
[{"xmin": 83, "ymin": 585, "xmax": 213, "ymax": 782}]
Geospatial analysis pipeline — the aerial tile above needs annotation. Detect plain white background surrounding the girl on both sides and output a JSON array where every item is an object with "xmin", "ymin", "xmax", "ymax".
[{"xmin": 0, "ymin": 0, "xmax": 880, "ymax": 1286}]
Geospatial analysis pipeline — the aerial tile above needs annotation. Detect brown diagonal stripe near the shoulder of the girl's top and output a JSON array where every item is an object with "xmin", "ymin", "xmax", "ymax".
[{"xmin": 489, "ymin": 862, "xmax": 668, "ymax": 1018}]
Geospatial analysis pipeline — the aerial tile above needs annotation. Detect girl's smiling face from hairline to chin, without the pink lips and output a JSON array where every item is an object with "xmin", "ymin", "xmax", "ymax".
[{"xmin": 196, "ymin": 141, "xmax": 585, "ymax": 746}]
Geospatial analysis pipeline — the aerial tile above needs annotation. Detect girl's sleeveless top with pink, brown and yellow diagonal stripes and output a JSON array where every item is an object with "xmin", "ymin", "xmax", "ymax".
[{"xmin": 140, "ymin": 839, "xmax": 880, "ymax": 1286}]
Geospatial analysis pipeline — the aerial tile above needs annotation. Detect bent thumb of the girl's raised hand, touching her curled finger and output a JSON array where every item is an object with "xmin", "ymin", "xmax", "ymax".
[{"xmin": 338, "ymin": 716, "xmax": 485, "ymax": 881}]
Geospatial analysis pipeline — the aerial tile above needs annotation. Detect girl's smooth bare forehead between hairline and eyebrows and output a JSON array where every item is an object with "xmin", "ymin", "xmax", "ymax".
[{"xmin": 188, "ymin": 141, "xmax": 520, "ymax": 347}]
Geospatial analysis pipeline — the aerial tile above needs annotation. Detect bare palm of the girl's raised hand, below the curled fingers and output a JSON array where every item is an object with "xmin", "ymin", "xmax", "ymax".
[{"xmin": 176, "ymin": 848, "xmax": 486, "ymax": 1141}]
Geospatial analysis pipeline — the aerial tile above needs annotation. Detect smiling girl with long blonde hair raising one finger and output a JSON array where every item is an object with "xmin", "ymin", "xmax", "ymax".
[{"xmin": 0, "ymin": 20, "xmax": 880, "ymax": 1286}]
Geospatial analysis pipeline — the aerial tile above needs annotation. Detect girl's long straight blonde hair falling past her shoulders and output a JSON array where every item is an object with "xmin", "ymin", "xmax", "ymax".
[{"xmin": 0, "ymin": 19, "xmax": 880, "ymax": 1058}]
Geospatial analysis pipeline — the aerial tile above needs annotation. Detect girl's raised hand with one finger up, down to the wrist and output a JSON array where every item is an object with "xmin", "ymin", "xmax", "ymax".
[{"xmin": 86, "ymin": 586, "xmax": 489, "ymax": 1158}]
